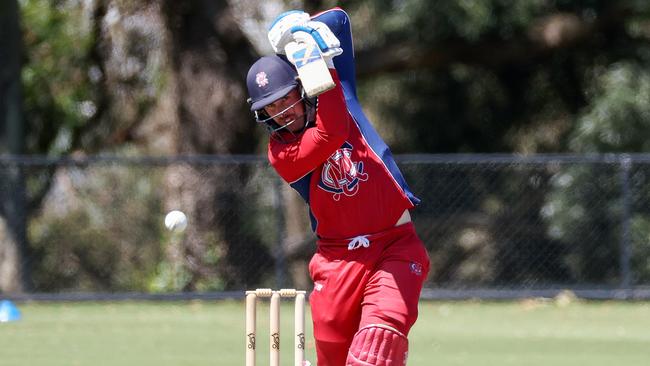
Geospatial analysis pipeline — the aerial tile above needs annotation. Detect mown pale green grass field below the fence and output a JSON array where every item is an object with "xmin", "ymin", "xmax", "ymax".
[{"xmin": 0, "ymin": 301, "xmax": 650, "ymax": 366}]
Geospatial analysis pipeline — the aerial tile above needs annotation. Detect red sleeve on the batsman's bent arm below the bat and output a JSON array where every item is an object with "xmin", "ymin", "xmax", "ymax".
[{"xmin": 268, "ymin": 69, "xmax": 351, "ymax": 183}]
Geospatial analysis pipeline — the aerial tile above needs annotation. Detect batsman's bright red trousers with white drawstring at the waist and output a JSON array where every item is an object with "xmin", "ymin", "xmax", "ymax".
[{"xmin": 309, "ymin": 222, "xmax": 429, "ymax": 366}]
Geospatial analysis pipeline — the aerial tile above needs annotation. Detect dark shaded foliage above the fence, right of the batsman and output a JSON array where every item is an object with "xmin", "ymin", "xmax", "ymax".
[{"xmin": 344, "ymin": 0, "xmax": 649, "ymax": 153}]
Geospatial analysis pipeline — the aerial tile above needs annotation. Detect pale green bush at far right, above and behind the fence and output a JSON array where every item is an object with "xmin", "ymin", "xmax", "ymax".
[{"xmin": 544, "ymin": 61, "xmax": 650, "ymax": 281}]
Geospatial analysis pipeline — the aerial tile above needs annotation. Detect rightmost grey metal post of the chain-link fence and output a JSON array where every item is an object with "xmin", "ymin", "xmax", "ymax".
[{"xmin": 620, "ymin": 154, "xmax": 632, "ymax": 297}]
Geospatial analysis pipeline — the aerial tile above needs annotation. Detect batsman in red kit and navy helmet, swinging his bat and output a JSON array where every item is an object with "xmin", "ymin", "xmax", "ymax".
[{"xmin": 246, "ymin": 8, "xmax": 429, "ymax": 366}]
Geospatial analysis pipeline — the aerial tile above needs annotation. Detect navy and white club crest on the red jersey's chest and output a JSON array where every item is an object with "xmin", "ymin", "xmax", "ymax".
[{"xmin": 318, "ymin": 142, "xmax": 368, "ymax": 201}]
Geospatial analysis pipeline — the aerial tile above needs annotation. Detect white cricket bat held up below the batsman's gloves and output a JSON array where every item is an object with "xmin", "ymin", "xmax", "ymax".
[{"xmin": 284, "ymin": 42, "xmax": 335, "ymax": 98}]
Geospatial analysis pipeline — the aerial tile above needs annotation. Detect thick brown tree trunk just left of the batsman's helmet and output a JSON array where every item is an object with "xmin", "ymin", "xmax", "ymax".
[{"xmin": 164, "ymin": 0, "xmax": 272, "ymax": 290}]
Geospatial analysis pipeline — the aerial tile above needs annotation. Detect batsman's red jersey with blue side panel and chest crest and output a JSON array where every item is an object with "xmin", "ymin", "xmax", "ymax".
[{"xmin": 268, "ymin": 69, "xmax": 418, "ymax": 239}]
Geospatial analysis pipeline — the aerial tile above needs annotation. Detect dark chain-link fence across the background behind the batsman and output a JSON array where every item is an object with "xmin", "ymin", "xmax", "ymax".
[{"xmin": 0, "ymin": 155, "xmax": 650, "ymax": 297}]
